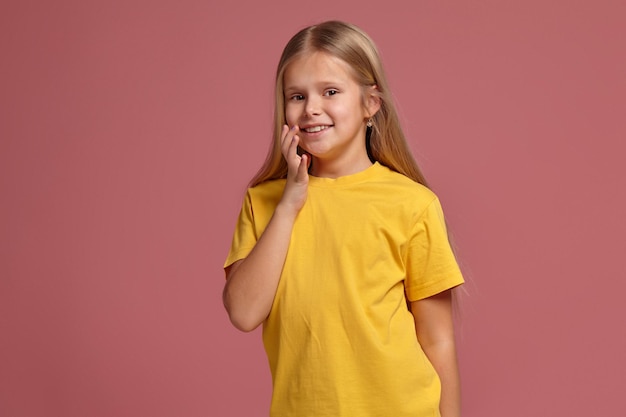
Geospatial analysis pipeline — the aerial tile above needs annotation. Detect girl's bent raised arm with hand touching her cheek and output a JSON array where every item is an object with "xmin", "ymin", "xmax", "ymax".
[{"xmin": 223, "ymin": 126, "xmax": 310, "ymax": 332}]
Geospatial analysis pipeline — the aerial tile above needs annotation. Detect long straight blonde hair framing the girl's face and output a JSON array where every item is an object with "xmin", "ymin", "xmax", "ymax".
[{"xmin": 250, "ymin": 21, "xmax": 427, "ymax": 187}]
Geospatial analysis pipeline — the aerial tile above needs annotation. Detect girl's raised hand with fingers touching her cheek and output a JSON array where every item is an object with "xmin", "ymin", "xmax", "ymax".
[{"xmin": 279, "ymin": 125, "xmax": 311, "ymax": 214}]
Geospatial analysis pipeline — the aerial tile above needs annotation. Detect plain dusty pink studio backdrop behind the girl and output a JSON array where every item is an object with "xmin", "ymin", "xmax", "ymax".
[{"xmin": 0, "ymin": 0, "xmax": 626, "ymax": 417}]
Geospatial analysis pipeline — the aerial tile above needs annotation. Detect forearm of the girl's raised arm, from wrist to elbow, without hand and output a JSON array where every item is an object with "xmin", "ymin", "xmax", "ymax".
[{"xmin": 223, "ymin": 205, "xmax": 297, "ymax": 331}]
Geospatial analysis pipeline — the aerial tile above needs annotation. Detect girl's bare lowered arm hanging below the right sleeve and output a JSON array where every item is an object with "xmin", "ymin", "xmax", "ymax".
[{"xmin": 411, "ymin": 290, "xmax": 461, "ymax": 417}]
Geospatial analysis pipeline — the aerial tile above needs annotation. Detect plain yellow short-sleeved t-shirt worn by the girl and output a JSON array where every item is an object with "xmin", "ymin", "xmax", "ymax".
[{"xmin": 225, "ymin": 163, "xmax": 463, "ymax": 417}]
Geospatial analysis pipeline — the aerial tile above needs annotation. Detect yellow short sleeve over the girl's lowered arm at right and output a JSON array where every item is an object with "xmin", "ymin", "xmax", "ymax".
[{"xmin": 405, "ymin": 198, "xmax": 463, "ymax": 301}]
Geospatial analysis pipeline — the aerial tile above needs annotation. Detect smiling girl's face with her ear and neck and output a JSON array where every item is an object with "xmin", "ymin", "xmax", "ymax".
[{"xmin": 283, "ymin": 52, "xmax": 380, "ymax": 175}]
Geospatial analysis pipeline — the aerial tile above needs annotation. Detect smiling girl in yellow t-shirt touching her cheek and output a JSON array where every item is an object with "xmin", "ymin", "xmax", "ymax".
[{"xmin": 224, "ymin": 21, "xmax": 463, "ymax": 417}]
